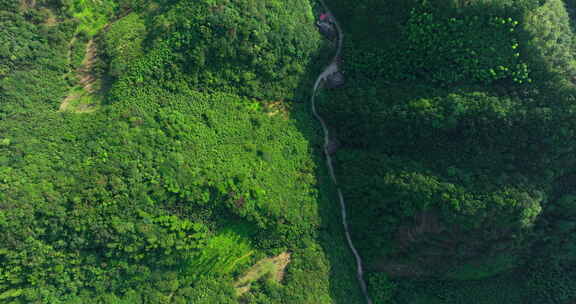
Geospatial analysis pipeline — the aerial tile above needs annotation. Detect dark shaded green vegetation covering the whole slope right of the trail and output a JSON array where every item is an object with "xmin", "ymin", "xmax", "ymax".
[{"xmin": 320, "ymin": 0, "xmax": 576, "ymax": 304}]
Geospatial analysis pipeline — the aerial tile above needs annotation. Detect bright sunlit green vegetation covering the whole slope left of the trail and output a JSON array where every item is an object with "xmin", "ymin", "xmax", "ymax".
[{"xmin": 0, "ymin": 0, "xmax": 360, "ymax": 304}]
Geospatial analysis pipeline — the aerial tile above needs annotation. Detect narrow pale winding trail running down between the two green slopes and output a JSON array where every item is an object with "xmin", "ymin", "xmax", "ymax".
[{"xmin": 310, "ymin": 0, "xmax": 372, "ymax": 304}]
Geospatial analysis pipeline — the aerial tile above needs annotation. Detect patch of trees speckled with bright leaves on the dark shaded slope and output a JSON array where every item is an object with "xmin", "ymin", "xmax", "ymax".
[{"xmin": 400, "ymin": 8, "xmax": 531, "ymax": 85}]
